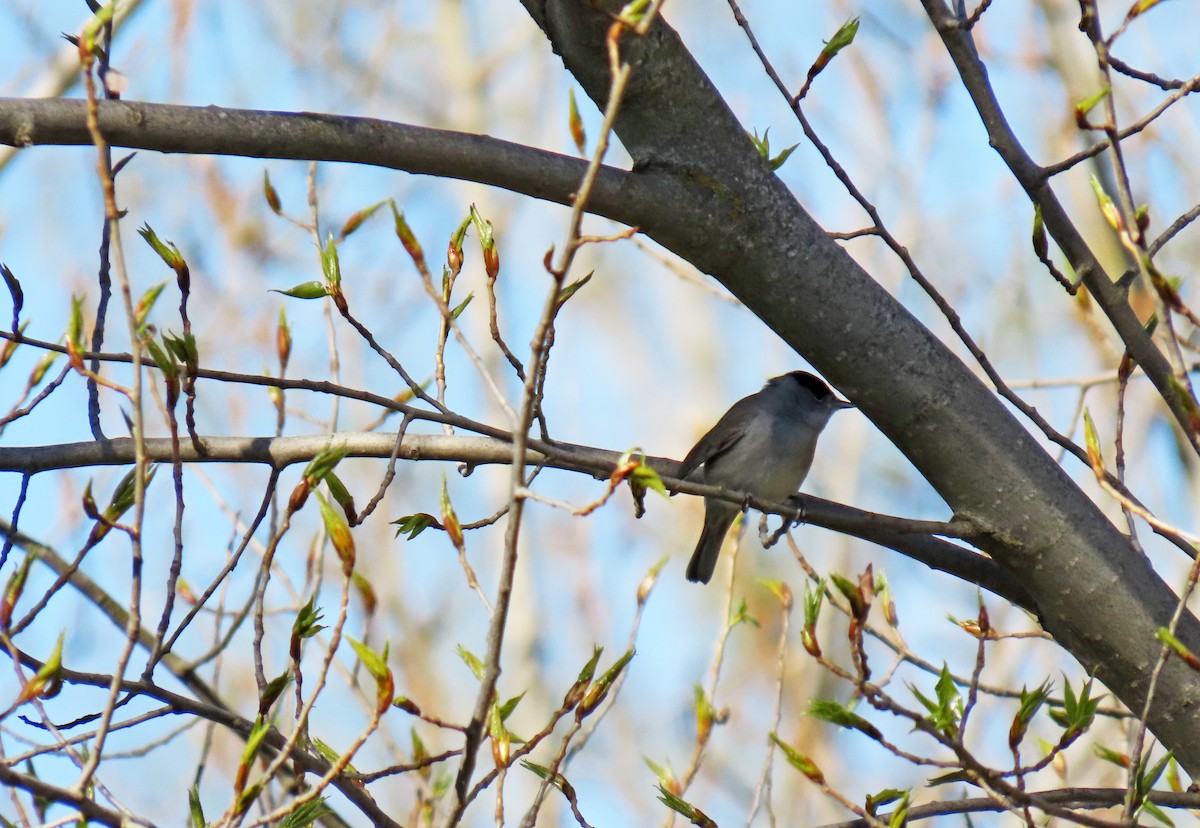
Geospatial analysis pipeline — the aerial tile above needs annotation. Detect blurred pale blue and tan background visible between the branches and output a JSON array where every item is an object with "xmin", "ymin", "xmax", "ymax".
[{"xmin": 0, "ymin": 0, "xmax": 1200, "ymax": 826}]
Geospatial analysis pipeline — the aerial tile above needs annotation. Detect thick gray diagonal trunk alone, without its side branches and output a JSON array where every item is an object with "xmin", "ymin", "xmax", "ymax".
[{"xmin": 523, "ymin": 0, "xmax": 1200, "ymax": 774}]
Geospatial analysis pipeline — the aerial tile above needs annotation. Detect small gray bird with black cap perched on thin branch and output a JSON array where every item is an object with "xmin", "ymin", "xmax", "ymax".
[{"xmin": 677, "ymin": 371, "xmax": 854, "ymax": 583}]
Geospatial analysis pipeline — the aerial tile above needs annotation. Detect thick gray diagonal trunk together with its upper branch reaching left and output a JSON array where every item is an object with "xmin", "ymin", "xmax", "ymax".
[{"xmin": 0, "ymin": 0, "xmax": 1200, "ymax": 775}]
